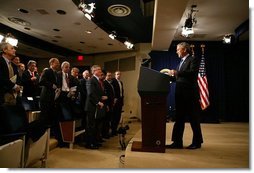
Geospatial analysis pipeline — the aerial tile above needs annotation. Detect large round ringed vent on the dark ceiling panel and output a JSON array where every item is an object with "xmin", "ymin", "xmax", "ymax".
[{"xmin": 108, "ymin": 4, "xmax": 131, "ymax": 17}]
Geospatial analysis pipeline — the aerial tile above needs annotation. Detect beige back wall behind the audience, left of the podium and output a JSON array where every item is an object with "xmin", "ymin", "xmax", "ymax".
[{"xmin": 35, "ymin": 43, "xmax": 151, "ymax": 119}]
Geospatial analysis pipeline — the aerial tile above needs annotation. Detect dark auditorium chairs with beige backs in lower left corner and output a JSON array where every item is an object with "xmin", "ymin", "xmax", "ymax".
[{"xmin": 0, "ymin": 100, "xmax": 50, "ymax": 168}]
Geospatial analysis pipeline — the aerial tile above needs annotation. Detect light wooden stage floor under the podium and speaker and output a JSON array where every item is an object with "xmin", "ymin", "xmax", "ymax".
[{"xmin": 124, "ymin": 122, "xmax": 250, "ymax": 169}]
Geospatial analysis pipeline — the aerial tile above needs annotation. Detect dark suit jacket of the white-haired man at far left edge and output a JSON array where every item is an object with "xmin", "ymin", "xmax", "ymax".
[{"xmin": 0, "ymin": 57, "xmax": 20, "ymax": 105}]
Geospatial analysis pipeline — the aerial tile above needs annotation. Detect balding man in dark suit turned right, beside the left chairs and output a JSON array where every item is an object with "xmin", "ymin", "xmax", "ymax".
[{"xmin": 39, "ymin": 58, "xmax": 59, "ymax": 125}]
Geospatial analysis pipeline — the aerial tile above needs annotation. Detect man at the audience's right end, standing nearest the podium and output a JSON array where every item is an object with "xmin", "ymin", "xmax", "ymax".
[{"xmin": 112, "ymin": 71, "xmax": 124, "ymax": 136}]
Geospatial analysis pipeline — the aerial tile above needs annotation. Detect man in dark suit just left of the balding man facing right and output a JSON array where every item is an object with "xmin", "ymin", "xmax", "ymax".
[{"xmin": 22, "ymin": 60, "xmax": 40, "ymax": 97}]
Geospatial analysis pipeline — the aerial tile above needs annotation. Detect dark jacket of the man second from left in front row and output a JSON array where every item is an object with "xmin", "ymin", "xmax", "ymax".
[{"xmin": 21, "ymin": 70, "xmax": 40, "ymax": 97}]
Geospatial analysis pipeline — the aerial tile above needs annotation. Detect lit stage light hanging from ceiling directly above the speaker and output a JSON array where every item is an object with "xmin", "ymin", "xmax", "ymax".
[{"xmin": 181, "ymin": 5, "xmax": 198, "ymax": 38}]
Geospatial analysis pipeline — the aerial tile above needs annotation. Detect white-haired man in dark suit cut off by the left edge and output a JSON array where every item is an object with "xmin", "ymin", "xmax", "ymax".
[{"xmin": 0, "ymin": 43, "xmax": 21, "ymax": 105}]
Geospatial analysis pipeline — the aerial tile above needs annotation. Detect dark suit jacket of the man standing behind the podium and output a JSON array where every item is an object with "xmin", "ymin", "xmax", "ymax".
[{"xmin": 175, "ymin": 56, "xmax": 199, "ymax": 107}]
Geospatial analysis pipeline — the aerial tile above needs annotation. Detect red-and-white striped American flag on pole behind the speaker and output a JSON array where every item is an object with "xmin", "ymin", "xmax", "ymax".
[{"xmin": 198, "ymin": 54, "xmax": 210, "ymax": 110}]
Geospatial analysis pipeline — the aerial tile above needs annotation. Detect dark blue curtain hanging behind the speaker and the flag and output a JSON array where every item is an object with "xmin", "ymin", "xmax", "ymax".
[{"xmin": 150, "ymin": 42, "xmax": 249, "ymax": 123}]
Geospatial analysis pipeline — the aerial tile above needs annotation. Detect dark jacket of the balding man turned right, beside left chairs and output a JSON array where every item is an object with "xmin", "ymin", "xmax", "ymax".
[{"xmin": 39, "ymin": 68, "xmax": 57, "ymax": 107}]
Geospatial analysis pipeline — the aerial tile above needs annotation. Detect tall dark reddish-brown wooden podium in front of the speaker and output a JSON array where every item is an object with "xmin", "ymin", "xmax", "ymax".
[{"xmin": 131, "ymin": 66, "xmax": 170, "ymax": 153}]
